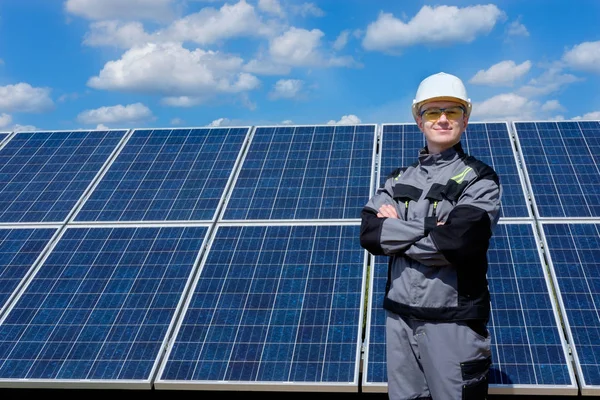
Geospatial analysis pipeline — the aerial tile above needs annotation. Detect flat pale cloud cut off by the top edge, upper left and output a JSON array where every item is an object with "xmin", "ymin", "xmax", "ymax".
[{"xmin": 65, "ymin": 0, "xmax": 175, "ymax": 21}]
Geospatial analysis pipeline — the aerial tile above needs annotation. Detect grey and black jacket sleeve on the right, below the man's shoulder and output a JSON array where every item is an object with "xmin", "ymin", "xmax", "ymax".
[{"xmin": 404, "ymin": 173, "xmax": 501, "ymax": 266}]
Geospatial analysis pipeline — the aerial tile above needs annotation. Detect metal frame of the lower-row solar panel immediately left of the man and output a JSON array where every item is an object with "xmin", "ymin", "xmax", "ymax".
[{"xmin": 154, "ymin": 220, "xmax": 368, "ymax": 393}]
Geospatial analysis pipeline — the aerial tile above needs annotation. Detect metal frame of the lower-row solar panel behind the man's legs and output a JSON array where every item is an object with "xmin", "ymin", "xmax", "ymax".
[{"xmin": 362, "ymin": 219, "xmax": 579, "ymax": 395}]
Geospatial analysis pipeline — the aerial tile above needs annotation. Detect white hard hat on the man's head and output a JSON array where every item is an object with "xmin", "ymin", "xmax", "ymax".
[{"xmin": 412, "ymin": 72, "xmax": 471, "ymax": 121}]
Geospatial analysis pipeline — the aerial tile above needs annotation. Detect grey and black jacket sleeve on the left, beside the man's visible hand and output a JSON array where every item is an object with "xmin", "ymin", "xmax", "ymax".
[{"xmin": 360, "ymin": 178, "xmax": 432, "ymax": 255}]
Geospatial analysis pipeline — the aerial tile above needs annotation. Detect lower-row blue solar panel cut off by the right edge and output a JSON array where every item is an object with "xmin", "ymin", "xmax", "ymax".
[{"xmin": 542, "ymin": 221, "xmax": 600, "ymax": 395}]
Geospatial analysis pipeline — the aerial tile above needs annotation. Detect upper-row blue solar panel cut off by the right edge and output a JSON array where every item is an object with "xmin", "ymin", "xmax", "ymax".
[{"xmin": 514, "ymin": 121, "xmax": 600, "ymax": 217}]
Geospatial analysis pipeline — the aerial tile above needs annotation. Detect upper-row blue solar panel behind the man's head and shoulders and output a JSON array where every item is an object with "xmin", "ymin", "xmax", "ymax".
[{"xmin": 379, "ymin": 122, "xmax": 531, "ymax": 218}]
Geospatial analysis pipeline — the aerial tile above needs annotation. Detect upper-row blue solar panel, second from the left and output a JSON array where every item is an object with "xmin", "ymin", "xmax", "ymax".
[{"xmin": 75, "ymin": 127, "xmax": 249, "ymax": 221}]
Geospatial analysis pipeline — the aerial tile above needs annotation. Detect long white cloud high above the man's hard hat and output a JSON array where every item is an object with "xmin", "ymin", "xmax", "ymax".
[{"xmin": 363, "ymin": 4, "xmax": 505, "ymax": 51}]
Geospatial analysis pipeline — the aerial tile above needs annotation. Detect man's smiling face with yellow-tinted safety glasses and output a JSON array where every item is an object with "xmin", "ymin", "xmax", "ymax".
[{"xmin": 417, "ymin": 101, "xmax": 469, "ymax": 153}]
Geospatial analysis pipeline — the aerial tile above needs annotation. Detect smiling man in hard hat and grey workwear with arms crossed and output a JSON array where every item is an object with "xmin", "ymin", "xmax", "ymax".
[{"xmin": 360, "ymin": 72, "xmax": 501, "ymax": 400}]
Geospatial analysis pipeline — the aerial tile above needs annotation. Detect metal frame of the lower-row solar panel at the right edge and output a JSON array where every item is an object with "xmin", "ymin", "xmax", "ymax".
[{"xmin": 538, "ymin": 218, "xmax": 600, "ymax": 396}]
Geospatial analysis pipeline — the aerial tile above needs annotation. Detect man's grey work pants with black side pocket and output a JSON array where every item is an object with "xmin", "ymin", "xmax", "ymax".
[{"xmin": 386, "ymin": 311, "xmax": 491, "ymax": 400}]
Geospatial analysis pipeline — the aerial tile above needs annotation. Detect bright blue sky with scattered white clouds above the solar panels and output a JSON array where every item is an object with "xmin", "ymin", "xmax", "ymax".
[{"xmin": 0, "ymin": 0, "xmax": 600, "ymax": 131}]
